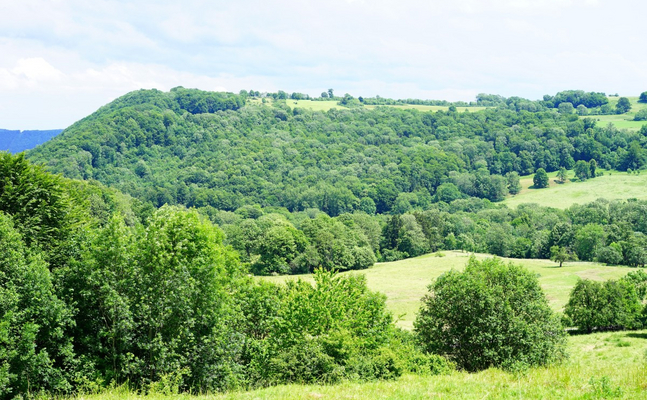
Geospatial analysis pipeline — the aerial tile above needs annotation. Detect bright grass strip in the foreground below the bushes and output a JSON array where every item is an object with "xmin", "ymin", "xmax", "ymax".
[{"xmin": 77, "ymin": 331, "xmax": 647, "ymax": 400}]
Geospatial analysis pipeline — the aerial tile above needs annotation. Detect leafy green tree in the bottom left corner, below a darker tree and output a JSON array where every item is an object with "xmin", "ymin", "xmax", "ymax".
[{"xmin": 0, "ymin": 212, "xmax": 74, "ymax": 399}]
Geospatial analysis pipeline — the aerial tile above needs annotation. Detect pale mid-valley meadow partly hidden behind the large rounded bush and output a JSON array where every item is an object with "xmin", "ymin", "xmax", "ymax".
[{"xmin": 261, "ymin": 251, "xmax": 632, "ymax": 329}]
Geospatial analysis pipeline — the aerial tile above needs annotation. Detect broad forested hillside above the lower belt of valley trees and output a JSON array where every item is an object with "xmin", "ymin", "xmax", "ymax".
[{"xmin": 28, "ymin": 88, "xmax": 647, "ymax": 216}]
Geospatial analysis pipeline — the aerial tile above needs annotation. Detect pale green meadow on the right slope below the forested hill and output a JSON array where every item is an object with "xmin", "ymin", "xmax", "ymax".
[{"xmin": 503, "ymin": 171, "xmax": 647, "ymax": 209}]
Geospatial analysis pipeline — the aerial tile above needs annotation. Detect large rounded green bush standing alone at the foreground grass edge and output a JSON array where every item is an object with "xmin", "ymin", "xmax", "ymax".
[{"xmin": 414, "ymin": 257, "xmax": 566, "ymax": 371}]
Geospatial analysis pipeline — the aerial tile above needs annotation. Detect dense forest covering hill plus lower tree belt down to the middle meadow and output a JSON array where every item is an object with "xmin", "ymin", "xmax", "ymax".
[{"xmin": 28, "ymin": 88, "xmax": 647, "ymax": 274}]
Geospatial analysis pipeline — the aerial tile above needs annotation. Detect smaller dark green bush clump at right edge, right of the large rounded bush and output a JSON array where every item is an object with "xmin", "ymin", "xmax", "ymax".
[{"xmin": 564, "ymin": 279, "xmax": 642, "ymax": 333}]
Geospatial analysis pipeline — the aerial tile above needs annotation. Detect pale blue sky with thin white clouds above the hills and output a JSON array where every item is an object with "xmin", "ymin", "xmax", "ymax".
[{"xmin": 0, "ymin": 0, "xmax": 647, "ymax": 130}]
